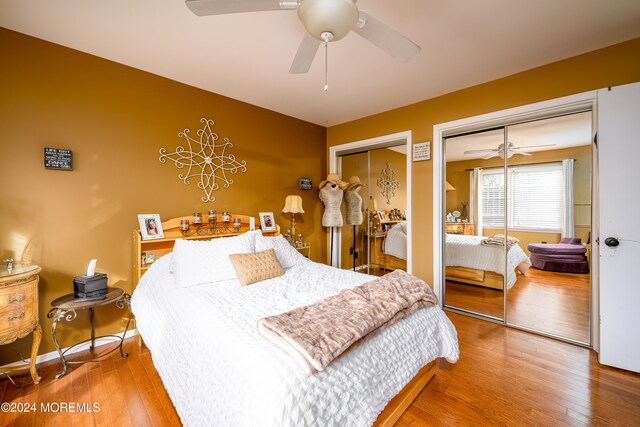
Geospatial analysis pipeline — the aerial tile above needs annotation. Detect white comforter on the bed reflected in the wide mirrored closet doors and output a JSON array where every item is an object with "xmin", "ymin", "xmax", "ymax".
[{"xmin": 445, "ymin": 234, "xmax": 531, "ymax": 289}]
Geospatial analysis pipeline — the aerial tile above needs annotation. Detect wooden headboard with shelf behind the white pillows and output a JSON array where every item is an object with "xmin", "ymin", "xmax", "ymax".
[{"xmin": 133, "ymin": 214, "xmax": 280, "ymax": 286}]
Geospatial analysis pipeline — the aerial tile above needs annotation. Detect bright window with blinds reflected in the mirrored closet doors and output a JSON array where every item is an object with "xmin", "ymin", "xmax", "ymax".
[{"xmin": 481, "ymin": 163, "xmax": 563, "ymax": 231}]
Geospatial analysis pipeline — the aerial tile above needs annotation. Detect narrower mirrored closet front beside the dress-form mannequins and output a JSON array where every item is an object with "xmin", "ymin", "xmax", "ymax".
[{"xmin": 339, "ymin": 143, "xmax": 407, "ymax": 275}]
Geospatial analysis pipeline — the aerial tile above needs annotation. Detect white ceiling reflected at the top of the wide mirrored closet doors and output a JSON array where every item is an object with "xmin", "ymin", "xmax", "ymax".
[{"xmin": 445, "ymin": 111, "xmax": 592, "ymax": 162}]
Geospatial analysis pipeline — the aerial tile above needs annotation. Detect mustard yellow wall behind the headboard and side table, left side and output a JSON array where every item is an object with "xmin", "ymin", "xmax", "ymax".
[{"xmin": 0, "ymin": 29, "xmax": 326, "ymax": 364}]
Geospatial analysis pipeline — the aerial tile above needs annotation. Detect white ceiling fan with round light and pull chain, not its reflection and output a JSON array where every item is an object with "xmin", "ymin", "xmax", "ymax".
[{"xmin": 185, "ymin": 0, "xmax": 421, "ymax": 83}]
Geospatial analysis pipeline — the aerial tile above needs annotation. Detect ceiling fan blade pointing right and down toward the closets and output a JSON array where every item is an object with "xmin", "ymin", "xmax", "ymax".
[{"xmin": 353, "ymin": 11, "xmax": 421, "ymax": 61}]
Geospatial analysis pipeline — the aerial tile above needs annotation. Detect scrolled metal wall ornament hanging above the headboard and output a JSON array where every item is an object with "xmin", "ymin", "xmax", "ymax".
[{"xmin": 159, "ymin": 118, "xmax": 247, "ymax": 202}]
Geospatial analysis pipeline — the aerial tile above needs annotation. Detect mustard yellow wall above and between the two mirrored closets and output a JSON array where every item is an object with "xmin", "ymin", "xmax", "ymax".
[{"xmin": 327, "ymin": 38, "xmax": 640, "ymax": 281}]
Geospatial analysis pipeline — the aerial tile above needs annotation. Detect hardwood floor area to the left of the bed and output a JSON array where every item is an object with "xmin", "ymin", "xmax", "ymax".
[{"xmin": 0, "ymin": 338, "xmax": 181, "ymax": 427}]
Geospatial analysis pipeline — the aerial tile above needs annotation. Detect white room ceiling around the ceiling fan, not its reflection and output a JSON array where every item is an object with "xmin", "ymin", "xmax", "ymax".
[{"xmin": 0, "ymin": 0, "xmax": 640, "ymax": 126}]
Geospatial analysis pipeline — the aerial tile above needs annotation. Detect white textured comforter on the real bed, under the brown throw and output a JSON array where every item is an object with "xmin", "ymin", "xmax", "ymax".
[{"xmin": 131, "ymin": 254, "xmax": 459, "ymax": 426}]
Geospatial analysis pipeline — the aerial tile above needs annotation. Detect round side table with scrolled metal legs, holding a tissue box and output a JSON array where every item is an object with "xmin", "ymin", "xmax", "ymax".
[{"xmin": 47, "ymin": 288, "xmax": 131, "ymax": 379}]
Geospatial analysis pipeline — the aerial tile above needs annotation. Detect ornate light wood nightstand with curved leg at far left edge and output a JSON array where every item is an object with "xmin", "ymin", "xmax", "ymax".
[{"xmin": 0, "ymin": 265, "xmax": 42, "ymax": 384}]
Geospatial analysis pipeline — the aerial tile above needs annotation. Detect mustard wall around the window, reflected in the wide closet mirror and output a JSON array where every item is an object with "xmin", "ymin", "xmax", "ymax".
[{"xmin": 446, "ymin": 145, "xmax": 591, "ymax": 255}]
